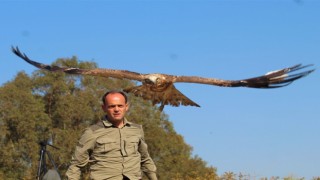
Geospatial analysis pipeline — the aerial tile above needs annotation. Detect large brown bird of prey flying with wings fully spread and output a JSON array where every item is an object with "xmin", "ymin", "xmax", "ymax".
[{"xmin": 12, "ymin": 47, "xmax": 315, "ymax": 111}]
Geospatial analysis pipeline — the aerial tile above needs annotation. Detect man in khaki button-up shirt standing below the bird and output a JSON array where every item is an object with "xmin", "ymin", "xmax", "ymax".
[{"xmin": 66, "ymin": 91, "xmax": 157, "ymax": 180}]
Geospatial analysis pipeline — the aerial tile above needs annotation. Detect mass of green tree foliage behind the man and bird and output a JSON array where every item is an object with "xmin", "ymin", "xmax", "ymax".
[{"xmin": 0, "ymin": 57, "xmax": 218, "ymax": 180}]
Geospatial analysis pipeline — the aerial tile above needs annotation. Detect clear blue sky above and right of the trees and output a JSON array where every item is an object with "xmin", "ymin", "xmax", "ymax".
[{"xmin": 0, "ymin": 0, "xmax": 320, "ymax": 179}]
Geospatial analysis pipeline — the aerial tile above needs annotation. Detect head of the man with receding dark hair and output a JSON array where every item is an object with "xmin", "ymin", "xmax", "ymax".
[{"xmin": 102, "ymin": 93, "xmax": 129, "ymax": 123}]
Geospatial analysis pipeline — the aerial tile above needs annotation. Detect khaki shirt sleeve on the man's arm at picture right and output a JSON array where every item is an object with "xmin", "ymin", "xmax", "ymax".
[{"xmin": 139, "ymin": 128, "xmax": 157, "ymax": 180}]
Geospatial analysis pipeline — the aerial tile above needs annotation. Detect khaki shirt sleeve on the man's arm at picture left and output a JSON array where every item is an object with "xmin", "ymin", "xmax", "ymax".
[{"xmin": 66, "ymin": 128, "xmax": 95, "ymax": 180}]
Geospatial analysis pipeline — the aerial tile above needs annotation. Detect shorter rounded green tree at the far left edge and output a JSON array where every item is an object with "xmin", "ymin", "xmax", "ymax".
[{"xmin": 0, "ymin": 73, "xmax": 51, "ymax": 179}]
